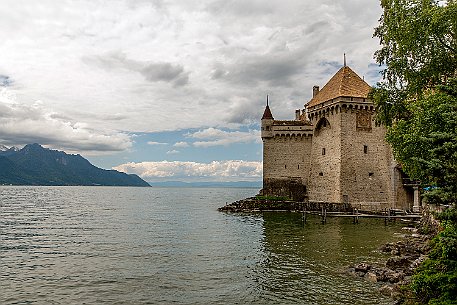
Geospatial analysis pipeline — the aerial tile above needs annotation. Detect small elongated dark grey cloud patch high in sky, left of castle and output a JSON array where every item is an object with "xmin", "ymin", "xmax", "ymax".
[{"xmin": 82, "ymin": 52, "xmax": 189, "ymax": 87}]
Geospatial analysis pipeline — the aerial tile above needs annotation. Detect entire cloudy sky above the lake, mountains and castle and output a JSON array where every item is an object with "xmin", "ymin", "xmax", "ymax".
[{"xmin": 0, "ymin": 0, "xmax": 381, "ymax": 182}]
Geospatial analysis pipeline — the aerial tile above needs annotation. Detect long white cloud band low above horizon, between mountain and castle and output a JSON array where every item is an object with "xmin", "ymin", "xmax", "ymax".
[{"xmin": 114, "ymin": 160, "xmax": 262, "ymax": 181}]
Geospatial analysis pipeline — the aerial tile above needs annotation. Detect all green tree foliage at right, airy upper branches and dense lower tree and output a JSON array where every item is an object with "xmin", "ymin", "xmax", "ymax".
[{"xmin": 371, "ymin": 0, "xmax": 457, "ymax": 204}]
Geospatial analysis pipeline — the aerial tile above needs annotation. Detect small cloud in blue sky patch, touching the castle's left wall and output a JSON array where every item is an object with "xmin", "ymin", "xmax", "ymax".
[{"xmin": 187, "ymin": 127, "xmax": 260, "ymax": 147}]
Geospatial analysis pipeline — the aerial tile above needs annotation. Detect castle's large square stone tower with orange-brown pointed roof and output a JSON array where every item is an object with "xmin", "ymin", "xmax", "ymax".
[{"xmin": 305, "ymin": 65, "xmax": 402, "ymax": 209}]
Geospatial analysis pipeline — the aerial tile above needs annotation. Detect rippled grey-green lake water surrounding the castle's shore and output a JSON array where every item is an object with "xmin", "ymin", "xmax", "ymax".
[{"xmin": 0, "ymin": 186, "xmax": 401, "ymax": 304}]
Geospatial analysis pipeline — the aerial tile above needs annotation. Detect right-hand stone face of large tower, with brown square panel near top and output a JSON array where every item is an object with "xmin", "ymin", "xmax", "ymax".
[{"xmin": 340, "ymin": 104, "xmax": 394, "ymax": 208}]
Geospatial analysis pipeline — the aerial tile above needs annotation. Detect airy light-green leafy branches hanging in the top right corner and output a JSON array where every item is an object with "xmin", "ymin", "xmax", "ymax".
[{"xmin": 373, "ymin": 0, "xmax": 457, "ymax": 126}]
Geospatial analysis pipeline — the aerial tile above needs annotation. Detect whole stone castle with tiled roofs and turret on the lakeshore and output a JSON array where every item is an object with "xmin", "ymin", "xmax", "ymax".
[{"xmin": 261, "ymin": 64, "xmax": 420, "ymax": 210}]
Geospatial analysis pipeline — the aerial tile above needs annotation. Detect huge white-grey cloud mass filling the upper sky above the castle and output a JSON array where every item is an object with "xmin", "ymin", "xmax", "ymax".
[{"xmin": 0, "ymin": 0, "xmax": 381, "ymax": 132}]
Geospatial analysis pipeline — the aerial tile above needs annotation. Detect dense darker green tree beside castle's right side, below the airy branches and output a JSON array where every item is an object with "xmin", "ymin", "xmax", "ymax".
[{"xmin": 387, "ymin": 80, "xmax": 457, "ymax": 204}]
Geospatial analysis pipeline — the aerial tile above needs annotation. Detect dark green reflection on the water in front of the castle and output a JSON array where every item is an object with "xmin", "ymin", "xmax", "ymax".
[{"xmin": 256, "ymin": 213, "xmax": 398, "ymax": 304}]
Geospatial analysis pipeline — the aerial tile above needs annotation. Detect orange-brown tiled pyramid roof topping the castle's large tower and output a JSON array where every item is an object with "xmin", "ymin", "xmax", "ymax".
[{"xmin": 307, "ymin": 66, "xmax": 371, "ymax": 107}]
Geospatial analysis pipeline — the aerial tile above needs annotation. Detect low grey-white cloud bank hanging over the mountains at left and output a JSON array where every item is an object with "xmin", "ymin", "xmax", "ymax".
[{"xmin": 0, "ymin": 89, "xmax": 132, "ymax": 154}]
